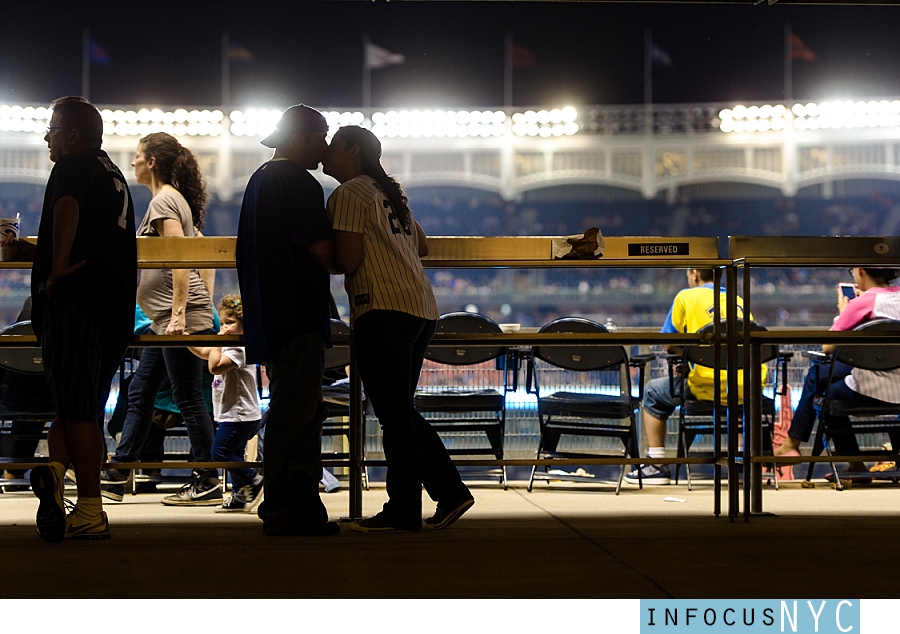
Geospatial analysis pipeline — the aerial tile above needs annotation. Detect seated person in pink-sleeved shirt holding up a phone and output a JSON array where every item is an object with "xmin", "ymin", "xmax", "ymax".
[{"xmin": 775, "ymin": 267, "xmax": 900, "ymax": 482}]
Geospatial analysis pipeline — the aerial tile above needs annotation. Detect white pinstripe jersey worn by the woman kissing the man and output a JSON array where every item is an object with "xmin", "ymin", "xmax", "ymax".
[{"xmin": 328, "ymin": 176, "xmax": 438, "ymax": 319}]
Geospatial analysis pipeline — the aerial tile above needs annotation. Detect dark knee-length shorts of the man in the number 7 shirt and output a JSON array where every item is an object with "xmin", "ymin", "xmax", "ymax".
[{"xmin": 41, "ymin": 299, "xmax": 131, "ymax": 420}]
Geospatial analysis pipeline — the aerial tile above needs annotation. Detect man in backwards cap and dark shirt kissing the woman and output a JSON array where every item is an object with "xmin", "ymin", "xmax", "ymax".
[{"xmin": 236, "ymin": 105, "xmax": 340, "ymax": 535}]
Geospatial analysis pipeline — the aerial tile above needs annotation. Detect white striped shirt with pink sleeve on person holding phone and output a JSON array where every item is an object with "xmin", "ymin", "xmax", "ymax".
[{"xmin": 831, "ymin": 286, "xmax": 900, "ymax": 403}]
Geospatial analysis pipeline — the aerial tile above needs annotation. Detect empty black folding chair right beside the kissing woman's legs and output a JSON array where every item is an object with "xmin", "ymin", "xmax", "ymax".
[{"xmin": 415, "ymin": 312, "xmax": 516, "ymax": 490}]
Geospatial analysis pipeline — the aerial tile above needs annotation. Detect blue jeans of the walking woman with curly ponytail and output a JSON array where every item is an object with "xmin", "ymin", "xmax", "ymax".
[{"xmin": 114, "ymin": 330, "xmax": 219, "ymax": 477}]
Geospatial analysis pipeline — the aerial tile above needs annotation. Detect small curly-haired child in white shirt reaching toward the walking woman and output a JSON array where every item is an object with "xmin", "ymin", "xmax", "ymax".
[{"xmin": 190, "ymin": 295, "xmax": 263, "ymax": 513}]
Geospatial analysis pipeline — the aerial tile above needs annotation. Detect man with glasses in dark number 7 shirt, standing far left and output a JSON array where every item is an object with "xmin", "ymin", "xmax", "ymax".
[{"xmin": 31, "ymin": 97, "xmax": 137, "ymax": 542}]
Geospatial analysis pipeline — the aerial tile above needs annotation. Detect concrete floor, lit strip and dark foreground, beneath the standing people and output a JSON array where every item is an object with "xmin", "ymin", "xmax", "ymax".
[{"xmin": 0, "ymin": 474, "xmax": 900, "ymax": 598}]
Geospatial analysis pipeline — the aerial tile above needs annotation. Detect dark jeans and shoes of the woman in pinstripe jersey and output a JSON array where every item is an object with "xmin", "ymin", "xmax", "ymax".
[{"xmin": 353, "ymin": 310, "xmax": 472, "ymax": 530}]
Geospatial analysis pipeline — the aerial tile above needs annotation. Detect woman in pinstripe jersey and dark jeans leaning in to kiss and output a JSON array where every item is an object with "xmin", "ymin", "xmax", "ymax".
[{"xmin": 322, "ymin": 126, "xmax": 474, "ymax": 532}]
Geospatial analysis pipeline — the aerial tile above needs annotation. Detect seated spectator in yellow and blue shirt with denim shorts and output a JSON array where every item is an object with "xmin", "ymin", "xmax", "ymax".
[{"xmin": 625, "ymin": 269, "xmax": 765, "ymax": 486}]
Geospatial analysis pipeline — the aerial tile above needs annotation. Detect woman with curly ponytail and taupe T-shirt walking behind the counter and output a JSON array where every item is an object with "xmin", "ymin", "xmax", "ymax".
[{"xmin": 102, "ymin": 132, "xmax": 222, "ymax": 506}]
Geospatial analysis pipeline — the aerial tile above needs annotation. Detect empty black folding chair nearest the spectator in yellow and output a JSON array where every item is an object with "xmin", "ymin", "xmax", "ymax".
[{"xmin": 526, "ymin": 317, "xmax": 654, "ymax": 495}]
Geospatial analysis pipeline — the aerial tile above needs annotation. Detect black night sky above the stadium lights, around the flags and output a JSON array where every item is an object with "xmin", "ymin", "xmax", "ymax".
[{"xmin": 0, "ymin": 0, "xmax": 900, "ymax": 108}]
